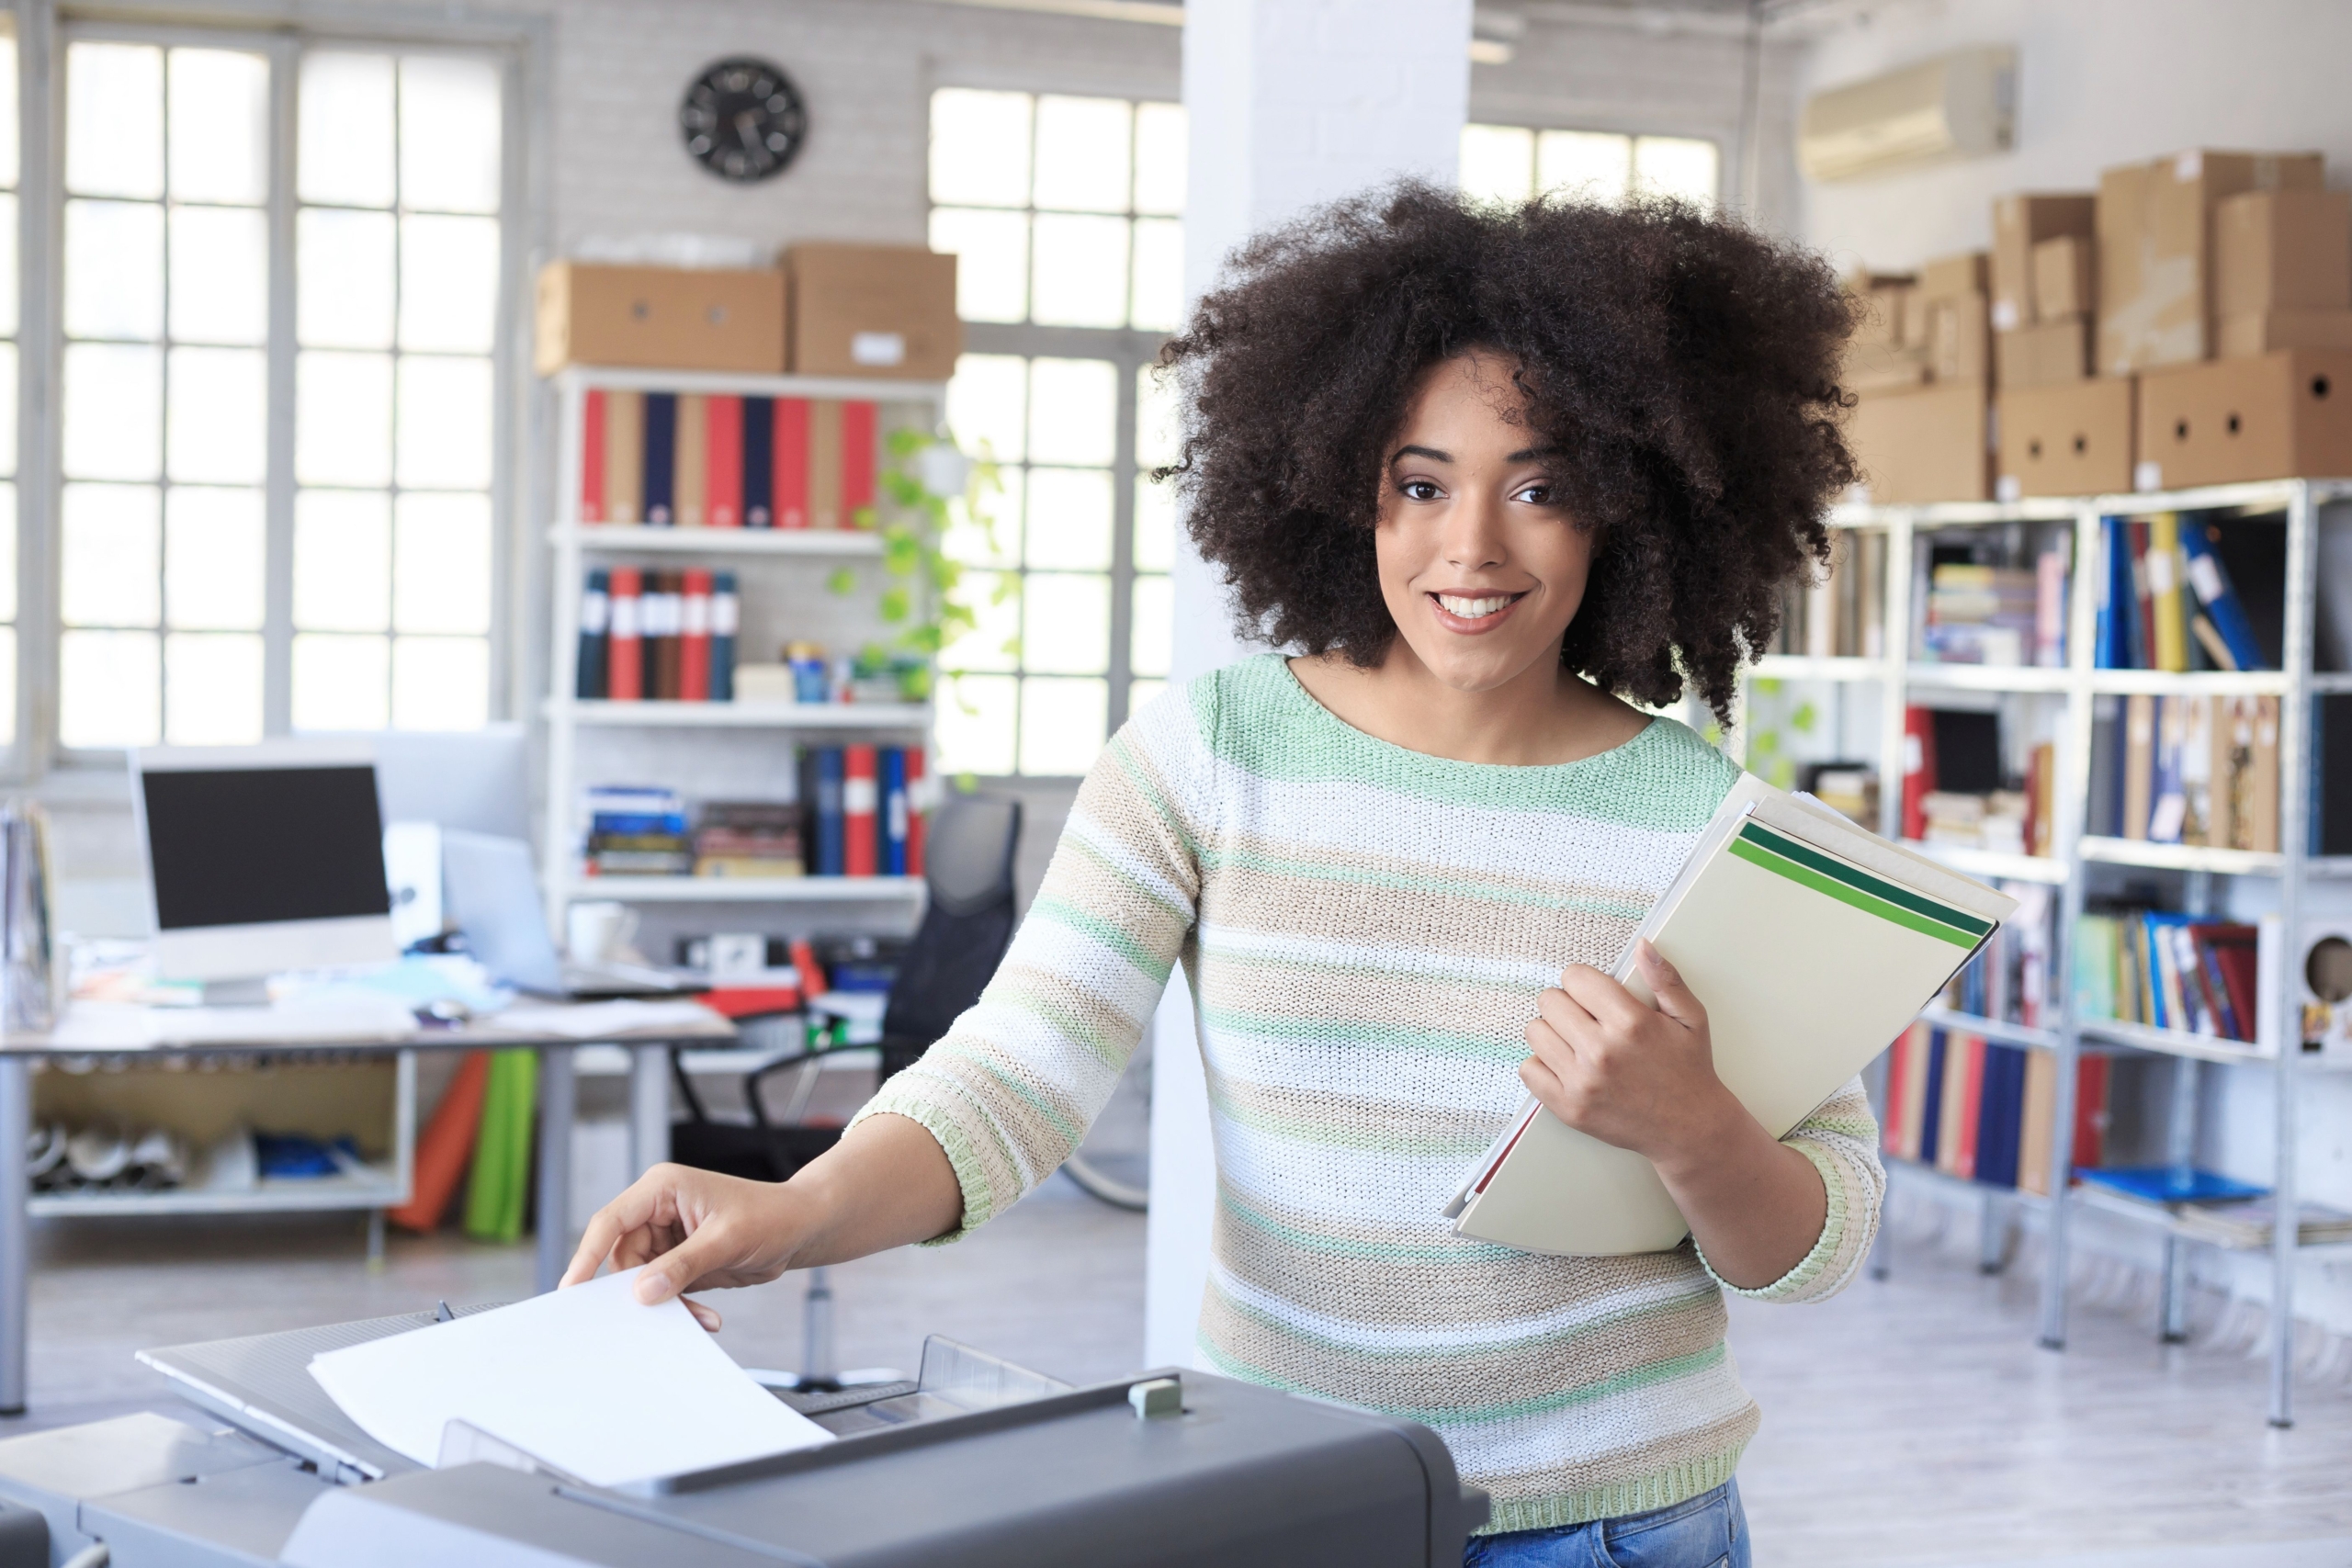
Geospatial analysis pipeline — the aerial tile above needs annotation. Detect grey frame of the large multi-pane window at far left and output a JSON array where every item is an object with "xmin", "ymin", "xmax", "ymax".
[{"xmin": 15, "ymin": 0, "xmax": 550, "ymax": 795}]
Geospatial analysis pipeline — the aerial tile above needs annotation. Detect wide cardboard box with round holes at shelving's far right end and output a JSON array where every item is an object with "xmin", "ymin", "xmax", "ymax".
[{"xmin": 2133, "ymin": 348, "xmax": 2352, "ymax": 489}]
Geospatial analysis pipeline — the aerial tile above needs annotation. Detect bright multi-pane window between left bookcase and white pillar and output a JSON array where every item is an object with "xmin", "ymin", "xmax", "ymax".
[{"xmin": 932, "ymin": 89, "xmax": 1185, "ymax": 776}]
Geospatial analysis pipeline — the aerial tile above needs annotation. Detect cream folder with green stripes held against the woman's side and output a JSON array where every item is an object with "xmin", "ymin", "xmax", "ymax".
[{"xmin": 1446, "ymin": 773, "xmax": 2018, "ymax": 1258}]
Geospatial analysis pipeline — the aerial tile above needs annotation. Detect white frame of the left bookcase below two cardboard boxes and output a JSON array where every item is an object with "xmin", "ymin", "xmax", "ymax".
[{"xmin": 541, "ymin": 367, "xmax": 948, "ymax": 931}]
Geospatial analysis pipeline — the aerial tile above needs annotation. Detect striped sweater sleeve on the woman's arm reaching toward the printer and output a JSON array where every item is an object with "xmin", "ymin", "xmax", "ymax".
[{"xmin": 852, "ymin": 677, "xmax": 1214, "ymax": 1241}]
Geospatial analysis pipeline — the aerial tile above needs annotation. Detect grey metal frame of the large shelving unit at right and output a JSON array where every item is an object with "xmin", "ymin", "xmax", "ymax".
[{"xmin": 1731, "ymin": 479, "xmax": 2352, "ymax": 1427}]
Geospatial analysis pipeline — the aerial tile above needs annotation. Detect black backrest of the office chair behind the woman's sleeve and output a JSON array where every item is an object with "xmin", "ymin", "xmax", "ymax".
[{"xmin": 882, "ymin": 795, "xmax": 1021, "ymax": 1046}]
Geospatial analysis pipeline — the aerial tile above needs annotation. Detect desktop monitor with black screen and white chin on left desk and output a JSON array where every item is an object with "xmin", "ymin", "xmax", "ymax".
[{"xmin": 130, "ymin": 739, "xmax": 400, "ymax": 980}]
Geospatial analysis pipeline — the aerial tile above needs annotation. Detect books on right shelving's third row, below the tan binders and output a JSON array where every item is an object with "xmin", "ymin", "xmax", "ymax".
[{"xmin": 2075, "ymin": 909, "xmax": 2260, "ymax": 1046}]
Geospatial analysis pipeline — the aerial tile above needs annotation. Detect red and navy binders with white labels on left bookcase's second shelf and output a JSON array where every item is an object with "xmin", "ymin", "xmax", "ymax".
[{"xmin": 571, "ymin": 567, "xmax": 741, "ymax": 703}]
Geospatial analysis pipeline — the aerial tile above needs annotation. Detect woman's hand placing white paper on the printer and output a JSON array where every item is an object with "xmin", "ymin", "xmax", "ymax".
[{"xmin": 562, "ymin": 1166, "xmax": 814, "ymax": 1331}]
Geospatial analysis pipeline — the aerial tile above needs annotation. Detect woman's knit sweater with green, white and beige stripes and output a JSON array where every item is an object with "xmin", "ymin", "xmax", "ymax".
[{"xmin": 861, "ymin": 656, "xmax": 1884, "ymax": 1530}]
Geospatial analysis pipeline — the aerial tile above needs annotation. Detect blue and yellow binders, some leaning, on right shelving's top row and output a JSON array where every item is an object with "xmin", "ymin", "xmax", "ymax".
[{"xmin": 2093, "ymin": 513, "xmax": 2277, "ymax": 670}]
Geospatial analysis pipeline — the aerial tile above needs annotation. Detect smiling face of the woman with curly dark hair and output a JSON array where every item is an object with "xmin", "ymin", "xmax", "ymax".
[{"xmin": 1374, "ymin": 353, "xmax": 1592, "ymax": 691}]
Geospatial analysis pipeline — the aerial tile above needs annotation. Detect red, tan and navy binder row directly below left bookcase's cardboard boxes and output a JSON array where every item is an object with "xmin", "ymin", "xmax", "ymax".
[{"xmin": 579, "ymin": 390, "xmax": 879, "ymax": 529}]
